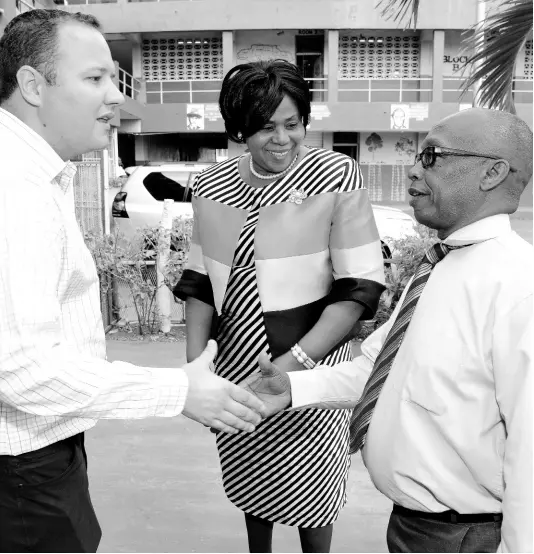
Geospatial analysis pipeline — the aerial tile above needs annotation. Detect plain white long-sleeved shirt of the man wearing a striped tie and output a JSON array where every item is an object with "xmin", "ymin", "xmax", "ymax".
[{"xmin": 289, "ymin": 215, "xmax": 533, "ymax": 552}]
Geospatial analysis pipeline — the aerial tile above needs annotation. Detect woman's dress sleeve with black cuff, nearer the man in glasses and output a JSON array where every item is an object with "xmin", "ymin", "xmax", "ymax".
[{"xmin": 328, "ymin": 159, "xmax": 385, "ymax": 320}]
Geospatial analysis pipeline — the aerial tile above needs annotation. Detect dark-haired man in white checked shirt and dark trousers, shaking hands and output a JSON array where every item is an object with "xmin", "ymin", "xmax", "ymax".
[{"xmin": 0, "ymin": 10, "xmax": 263, "ymax": 552}]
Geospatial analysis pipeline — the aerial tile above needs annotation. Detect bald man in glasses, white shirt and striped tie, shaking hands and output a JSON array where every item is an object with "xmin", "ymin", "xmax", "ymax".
[{"xmin": 244, "ymin": 109, "xmax": 533, "ymax": 552}]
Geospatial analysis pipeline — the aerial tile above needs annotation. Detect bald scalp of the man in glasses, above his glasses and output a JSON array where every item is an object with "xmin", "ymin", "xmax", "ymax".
[{"xmin": 429, "ymin": 108, "xmax": 532, "ymax": 183}]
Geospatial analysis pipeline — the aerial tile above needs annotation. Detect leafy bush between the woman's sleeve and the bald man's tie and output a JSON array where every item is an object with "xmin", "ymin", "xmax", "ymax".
[{"xmin": 356, "ymin": 224, "xmax": 437, "ymax": 340}]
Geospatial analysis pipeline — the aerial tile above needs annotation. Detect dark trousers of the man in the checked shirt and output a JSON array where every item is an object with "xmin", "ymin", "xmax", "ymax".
[{"xmin": 0, "ymin": 433, "xmax": 102, "ymax": 552}]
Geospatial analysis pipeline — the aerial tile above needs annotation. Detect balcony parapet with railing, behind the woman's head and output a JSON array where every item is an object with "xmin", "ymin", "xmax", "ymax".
[{"xmin": 121, "ymin": 74, "xmax": 532, "ymax": 133}]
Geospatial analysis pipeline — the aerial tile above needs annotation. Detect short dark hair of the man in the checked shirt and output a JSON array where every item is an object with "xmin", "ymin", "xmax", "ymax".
[{"xmin": 0, "ymin": 10, "xmax": 102, "ymax": 104}]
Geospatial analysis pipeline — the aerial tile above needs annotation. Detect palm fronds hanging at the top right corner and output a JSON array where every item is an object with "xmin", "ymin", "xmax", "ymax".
[{"xmin": 379, "ymin": 0, "xmax": 532, "ymax": 113}]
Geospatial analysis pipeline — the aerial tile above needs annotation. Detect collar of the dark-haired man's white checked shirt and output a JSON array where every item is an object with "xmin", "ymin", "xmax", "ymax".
[{"xmin": 0, "ymin": 108, "xmax": 76, "ymax": 191}]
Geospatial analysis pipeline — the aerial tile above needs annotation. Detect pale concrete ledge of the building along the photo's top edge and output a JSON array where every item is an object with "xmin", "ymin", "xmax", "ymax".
[{"xmin": 62, "ymin": 0, "xmax": 477, "ymax": 33}]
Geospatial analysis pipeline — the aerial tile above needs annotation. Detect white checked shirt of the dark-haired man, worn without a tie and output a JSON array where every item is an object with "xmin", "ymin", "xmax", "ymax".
[{"xmin": 0, "ymin": 108, "xmax": 188, "ymax": 455}]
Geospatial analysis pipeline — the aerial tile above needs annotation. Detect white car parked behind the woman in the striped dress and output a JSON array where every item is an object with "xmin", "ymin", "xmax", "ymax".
[{"xmin": 112, "ymin": 162, "xmax": 415, "ymax": 257}]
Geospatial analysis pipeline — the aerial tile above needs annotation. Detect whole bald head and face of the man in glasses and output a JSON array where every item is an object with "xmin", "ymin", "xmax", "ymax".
[{"xmin": 414, "ymin": 108, "xmax": 532, "ymax": 235}]
